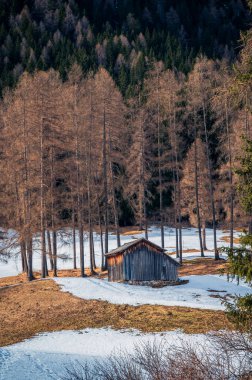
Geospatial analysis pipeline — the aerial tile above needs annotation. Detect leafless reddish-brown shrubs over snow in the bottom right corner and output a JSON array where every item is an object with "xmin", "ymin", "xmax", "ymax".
[{"xmin": 64, "ymin": 332, "xmax": 252, "ymax": 380}]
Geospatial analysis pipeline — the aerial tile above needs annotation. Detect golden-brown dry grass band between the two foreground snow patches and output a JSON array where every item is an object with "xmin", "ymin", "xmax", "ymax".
[{"xmin": 0, "ymin": 280, "xmax": 232, "ymax": 346}]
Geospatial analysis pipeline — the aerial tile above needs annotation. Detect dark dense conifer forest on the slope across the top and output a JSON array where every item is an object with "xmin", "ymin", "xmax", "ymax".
[{"xmin": 0, "ymin": 0, "xmax": 251, "ymax": 97}]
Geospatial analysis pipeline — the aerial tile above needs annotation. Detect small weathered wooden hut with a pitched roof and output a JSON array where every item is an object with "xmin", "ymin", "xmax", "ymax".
[{"xmin": 106, "ymin": 238, "xmax": 180, "ymax": 282}]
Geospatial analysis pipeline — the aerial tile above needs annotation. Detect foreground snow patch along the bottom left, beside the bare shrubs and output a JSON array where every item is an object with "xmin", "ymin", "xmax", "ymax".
[{"xmin": 0, "ymin": 329, "xmax": 206, "ymax": 380}]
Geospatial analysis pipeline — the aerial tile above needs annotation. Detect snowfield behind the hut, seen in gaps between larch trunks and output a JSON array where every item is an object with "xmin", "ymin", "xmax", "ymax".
[{"xmin": 0, "ymin": 226, "xmax": 240, "ymax": 277}]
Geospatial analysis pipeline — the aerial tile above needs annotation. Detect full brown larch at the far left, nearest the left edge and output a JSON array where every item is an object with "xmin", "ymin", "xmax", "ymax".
[{"xmin": 3, "ymin": 74, "xmax": 37, "ymax": 280}]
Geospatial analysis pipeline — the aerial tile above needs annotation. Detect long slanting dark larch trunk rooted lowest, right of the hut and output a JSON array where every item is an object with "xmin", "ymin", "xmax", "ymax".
[{"xmin": 203, "ymin": 102, "xmax": 220, "ymax": 260}]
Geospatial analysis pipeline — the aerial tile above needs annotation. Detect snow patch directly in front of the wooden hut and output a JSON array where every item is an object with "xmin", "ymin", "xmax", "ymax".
[{"xmin": 55, "ymin": 275, "xmax": 252, "ymax": 310}]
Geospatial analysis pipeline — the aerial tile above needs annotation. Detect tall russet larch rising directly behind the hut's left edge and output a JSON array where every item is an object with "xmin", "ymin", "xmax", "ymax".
[{"xmin": 94, "ymin": 68, "xmax": 125, "ymax": 264}]
